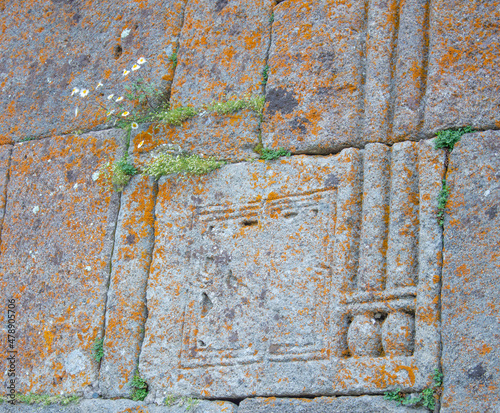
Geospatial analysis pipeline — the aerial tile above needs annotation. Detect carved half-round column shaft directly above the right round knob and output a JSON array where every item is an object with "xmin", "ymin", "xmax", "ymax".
[{"xmin": 386, "ymin": 142, "xmax": 419, "ymax": 288}]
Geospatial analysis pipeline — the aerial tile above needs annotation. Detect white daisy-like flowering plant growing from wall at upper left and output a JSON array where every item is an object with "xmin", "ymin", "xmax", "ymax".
[{"xmin": 71, "ymin": 57, "xmax": 168, "ymax": 130}]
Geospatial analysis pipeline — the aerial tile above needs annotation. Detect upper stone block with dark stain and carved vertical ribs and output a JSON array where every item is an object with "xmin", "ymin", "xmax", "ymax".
[{"xmin": 263, "ymin": 0, "xmax": 429, "ymax": 153}]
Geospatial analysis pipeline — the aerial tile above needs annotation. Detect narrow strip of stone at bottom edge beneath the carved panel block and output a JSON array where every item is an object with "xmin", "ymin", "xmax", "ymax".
[{"xmin": 238, "ymin": 396, "xmax": 428, "ymax": 413}]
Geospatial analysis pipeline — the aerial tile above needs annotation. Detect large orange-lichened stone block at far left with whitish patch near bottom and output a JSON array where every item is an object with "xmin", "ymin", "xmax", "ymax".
[{"xmin": 0, "ymin": 131, "xmax": 122, "ymax": 393}]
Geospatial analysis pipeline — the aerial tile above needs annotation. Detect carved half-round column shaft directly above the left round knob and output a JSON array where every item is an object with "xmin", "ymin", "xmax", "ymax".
[{"xmin": 358, "ymin": 143, "xmax": 391, "ymax": 291}]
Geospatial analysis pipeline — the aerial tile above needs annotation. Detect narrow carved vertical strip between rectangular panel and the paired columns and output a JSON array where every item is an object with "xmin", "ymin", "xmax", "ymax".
[{"xmin": 333, "ymin": 148, "xmax": 363, "ymax": 291}]
